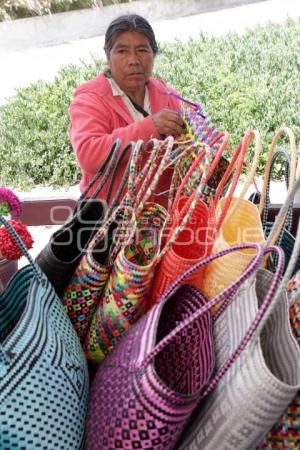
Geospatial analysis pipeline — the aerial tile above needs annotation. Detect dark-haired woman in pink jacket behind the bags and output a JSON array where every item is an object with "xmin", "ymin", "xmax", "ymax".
[{"xmin": 69, "ymin": 14, "xmax": 183, "ymax": 204}]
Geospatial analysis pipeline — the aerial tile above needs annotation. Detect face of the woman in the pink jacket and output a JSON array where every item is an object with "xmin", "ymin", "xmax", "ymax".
[{"xmin": 107, "ymin": 31, "xmax": 154, "ymax": 93}]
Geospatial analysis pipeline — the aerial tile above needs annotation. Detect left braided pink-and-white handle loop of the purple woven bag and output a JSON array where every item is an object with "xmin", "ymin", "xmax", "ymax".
[{"xmin": 142, "ymin": 243, "xmax": 263, "ymax": 367}]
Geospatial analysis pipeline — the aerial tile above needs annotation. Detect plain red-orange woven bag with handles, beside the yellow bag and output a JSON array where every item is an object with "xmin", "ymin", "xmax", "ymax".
[{"xmin": 149, "ymin": 139, "xmax": 228, "ymax": 307}]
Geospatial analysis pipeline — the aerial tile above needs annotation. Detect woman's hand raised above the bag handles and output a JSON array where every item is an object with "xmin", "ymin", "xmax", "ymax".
[{"xmin": 151, "ymin": 109, "xmax": 185, "ymax": 136}]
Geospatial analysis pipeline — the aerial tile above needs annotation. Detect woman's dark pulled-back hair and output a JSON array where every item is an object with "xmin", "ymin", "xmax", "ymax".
[{"xmin": 104, "ymin": 14, "xmax": 158, "ymax": 55}]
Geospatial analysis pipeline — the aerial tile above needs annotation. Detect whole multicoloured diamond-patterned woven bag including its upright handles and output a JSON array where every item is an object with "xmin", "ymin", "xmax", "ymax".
[{"xmin": 84, "ymin": 139, "xmax": 184, "ymax": 363}]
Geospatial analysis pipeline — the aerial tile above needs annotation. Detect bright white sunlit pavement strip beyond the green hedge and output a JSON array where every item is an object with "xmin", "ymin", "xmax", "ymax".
[{"xmin": 0, "ymin": 0, "xmax": 300, "ymax": 105}]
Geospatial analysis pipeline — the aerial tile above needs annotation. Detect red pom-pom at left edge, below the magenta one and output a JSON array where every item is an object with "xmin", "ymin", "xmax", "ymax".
[{"xmin": 0, "ymin": 219, "xmax": 33, "ymax": 259}]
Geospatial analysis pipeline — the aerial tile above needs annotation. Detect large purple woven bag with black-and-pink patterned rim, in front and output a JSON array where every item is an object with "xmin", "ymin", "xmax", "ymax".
[{"xmin": 86, "ymin": 244, "xmax": 263, "ymax": 450}]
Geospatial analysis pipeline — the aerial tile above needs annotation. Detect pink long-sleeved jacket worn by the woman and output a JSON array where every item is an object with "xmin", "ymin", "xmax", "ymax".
[{"xmin": 69, "ymin": 74, "xmax": 181, "ymax": 206}]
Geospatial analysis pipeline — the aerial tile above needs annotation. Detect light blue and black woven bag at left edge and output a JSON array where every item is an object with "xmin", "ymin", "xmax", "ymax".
[{"xmin": 0, "ymin": 216, "xmax": 88, "ymax": 450}]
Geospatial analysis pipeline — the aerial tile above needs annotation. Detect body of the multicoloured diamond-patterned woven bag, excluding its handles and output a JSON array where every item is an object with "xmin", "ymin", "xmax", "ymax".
[{"xmin": 84, "ymin": 203, "xmax": 168, "ymax": 363}]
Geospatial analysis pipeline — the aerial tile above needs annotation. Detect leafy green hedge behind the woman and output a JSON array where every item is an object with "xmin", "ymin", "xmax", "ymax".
[{"xmin": 0, "ymin": 19, "xmax": 300, "ymax": 188}]
